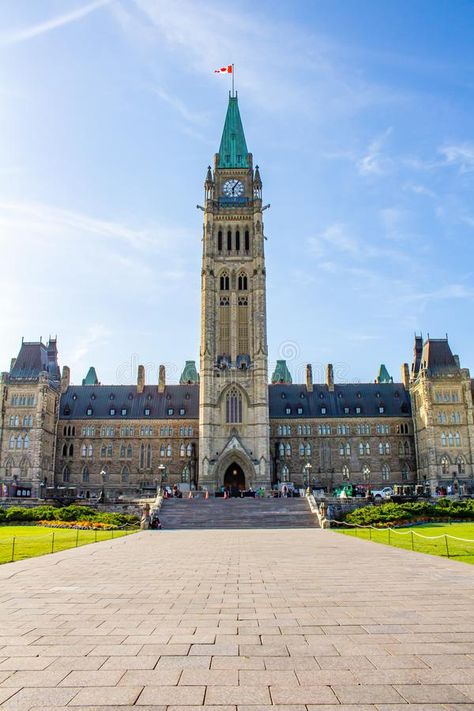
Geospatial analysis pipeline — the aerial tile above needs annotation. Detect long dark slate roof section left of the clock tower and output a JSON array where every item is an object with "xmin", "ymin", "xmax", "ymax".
[{"xmin": 59, "ymin": 385, "xmax": 199, "ymax": 422}]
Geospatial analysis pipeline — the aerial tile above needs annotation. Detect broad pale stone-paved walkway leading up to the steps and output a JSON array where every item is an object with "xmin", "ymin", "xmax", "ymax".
[{"xmin": 0, "ymin": 529, "xmax": 474, "ymax": 711}]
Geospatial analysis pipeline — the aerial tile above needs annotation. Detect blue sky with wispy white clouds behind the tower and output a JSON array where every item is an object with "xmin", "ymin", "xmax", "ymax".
[{"xmin": 0, "ymin": 0, "xmax": 474, "ymax": 383}]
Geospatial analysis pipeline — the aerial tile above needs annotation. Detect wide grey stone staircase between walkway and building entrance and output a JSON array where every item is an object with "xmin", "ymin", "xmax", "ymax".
[{"xmin": 159, "ymin": 497, "xmax": 319, "ymax": 530}]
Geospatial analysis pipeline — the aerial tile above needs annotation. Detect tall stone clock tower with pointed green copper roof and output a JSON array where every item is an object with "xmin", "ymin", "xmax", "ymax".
[{"xmin": 199, "ymin": 94, "xmax": 270, "ymax": 491}]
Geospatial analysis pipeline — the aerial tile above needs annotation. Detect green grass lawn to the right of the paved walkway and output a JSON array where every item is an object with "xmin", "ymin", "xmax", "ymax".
[{"xmin": 333, "ymin": 523, "xmax": 474, "ymax": 564}]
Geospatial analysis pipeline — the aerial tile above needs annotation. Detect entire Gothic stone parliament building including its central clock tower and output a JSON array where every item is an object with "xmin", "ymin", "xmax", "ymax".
[{"xmin": 0, "ymin": 95, "xmax": 474, "ymax": 499}]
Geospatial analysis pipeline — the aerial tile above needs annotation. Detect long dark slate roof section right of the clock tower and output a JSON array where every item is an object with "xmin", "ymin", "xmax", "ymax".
[{"xmin": 269, "ymin": 383, "xmax": 411, "ymax": 419}]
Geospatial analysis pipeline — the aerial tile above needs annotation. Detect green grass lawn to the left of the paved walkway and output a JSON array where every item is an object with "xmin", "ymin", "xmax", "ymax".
[{"xmin": 0, "ymin": 526, "xmax": 134, "ymax": 563}]
